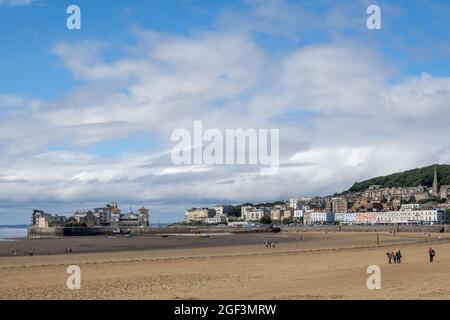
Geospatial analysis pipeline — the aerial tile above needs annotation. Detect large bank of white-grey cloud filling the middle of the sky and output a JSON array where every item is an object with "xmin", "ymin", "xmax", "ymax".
[{"xmin": 0, "ymin": 0, "xmax": 450, "ymax": 222}]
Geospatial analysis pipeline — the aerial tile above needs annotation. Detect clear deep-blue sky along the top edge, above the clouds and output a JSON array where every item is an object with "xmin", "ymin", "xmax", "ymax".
[{"xmin": 0, "ymin": 0, "xmax": 450, "ymax": 99}]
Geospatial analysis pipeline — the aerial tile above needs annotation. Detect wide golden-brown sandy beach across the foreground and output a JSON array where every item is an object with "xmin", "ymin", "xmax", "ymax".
[{"xmin": 0, "ymin": 233, "xmax": 450, "ymax": 300}]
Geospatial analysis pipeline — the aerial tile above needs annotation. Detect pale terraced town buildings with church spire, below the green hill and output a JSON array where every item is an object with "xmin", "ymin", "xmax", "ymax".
[{"xmin": 185, "ymin": 171, "xmax": 450, "ymax": 225}]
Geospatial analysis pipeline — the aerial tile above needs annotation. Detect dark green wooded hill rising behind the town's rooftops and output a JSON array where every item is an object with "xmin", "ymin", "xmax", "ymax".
[{"xmin": 348, "ymin": 164, "xmax": 450, "ymax": 191}]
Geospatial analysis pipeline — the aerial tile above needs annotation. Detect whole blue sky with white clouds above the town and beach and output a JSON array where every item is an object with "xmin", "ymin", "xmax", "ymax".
[{"xmin": 0, "ymin": 0, "xmax": 450, "ymax": 224}]
